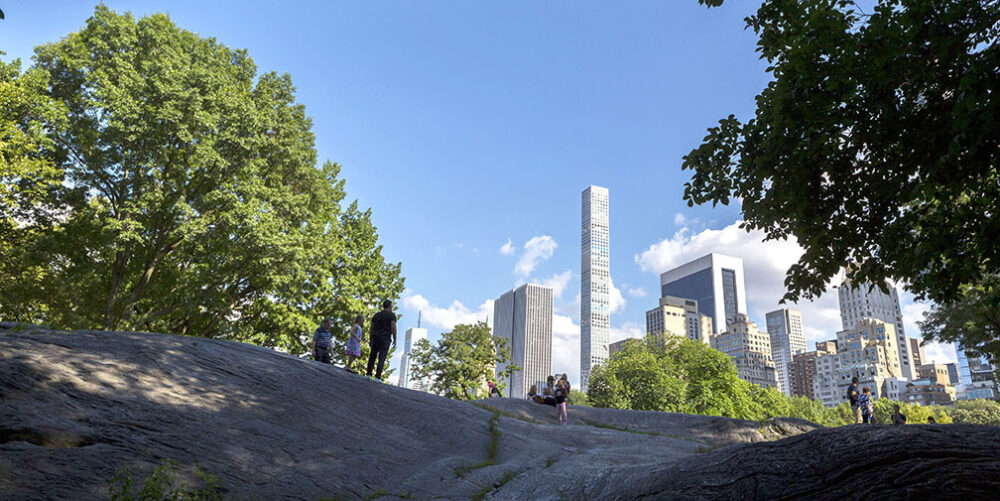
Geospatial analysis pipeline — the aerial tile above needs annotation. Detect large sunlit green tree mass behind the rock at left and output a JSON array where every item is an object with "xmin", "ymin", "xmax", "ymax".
[{"xmin": 0, "ymin": 5, "xmax": 403, "ymax": 353}]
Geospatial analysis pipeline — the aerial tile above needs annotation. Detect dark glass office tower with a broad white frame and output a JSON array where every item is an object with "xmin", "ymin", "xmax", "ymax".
[{"xmin": 660, "ymin": 253, "xmax": 747, "ymax": 333}]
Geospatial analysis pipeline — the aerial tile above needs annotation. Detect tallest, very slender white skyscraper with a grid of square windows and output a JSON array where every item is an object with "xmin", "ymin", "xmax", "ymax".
[{"xmin": 580, "ymin": 186, "xmax": 611, "ymax": 391}]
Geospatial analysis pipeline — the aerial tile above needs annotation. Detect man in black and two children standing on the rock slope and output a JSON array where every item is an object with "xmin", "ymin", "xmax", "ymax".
[{"xmin": 312, "ymin": 299, "xmax": 396, "ymax": 380}]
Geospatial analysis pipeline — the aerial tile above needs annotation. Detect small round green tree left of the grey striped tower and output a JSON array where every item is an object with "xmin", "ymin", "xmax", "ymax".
[{"xmin": 410, "ymin": 322, "xmax": 520, "ymax": 400}]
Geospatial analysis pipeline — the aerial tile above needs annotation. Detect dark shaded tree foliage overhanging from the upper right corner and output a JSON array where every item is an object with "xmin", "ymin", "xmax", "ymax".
[{"xmin": 683, "ymin": 0, "xmax": 1000, "ymax": 355}]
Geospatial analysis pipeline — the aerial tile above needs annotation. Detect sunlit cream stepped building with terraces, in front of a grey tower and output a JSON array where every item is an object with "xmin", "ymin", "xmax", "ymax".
[{"xmin": 813, "ymin": 318, "xmax": 902, "ymax": 407}]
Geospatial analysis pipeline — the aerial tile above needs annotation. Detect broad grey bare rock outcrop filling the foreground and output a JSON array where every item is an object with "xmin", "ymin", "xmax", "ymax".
[{"xmin": 0, "ymin": 324, "xmax": 1000, "ymax": 500}]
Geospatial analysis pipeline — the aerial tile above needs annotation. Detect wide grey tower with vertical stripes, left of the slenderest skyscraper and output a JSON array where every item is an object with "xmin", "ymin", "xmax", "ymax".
[{"xmin": 493, "ymin": 284, "xmax": 553, "ymax": 398}]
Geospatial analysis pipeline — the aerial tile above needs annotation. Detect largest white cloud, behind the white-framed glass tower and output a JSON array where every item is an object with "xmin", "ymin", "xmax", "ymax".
[{"xmin": 635, "ymin": 221, "xmax": 841, "ymax": 349}]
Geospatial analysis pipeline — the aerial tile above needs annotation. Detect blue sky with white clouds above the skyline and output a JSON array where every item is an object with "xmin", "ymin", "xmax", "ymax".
[{"xmin": 0, "ymin": 0, "xmax": 954, "ymax": 377}]
